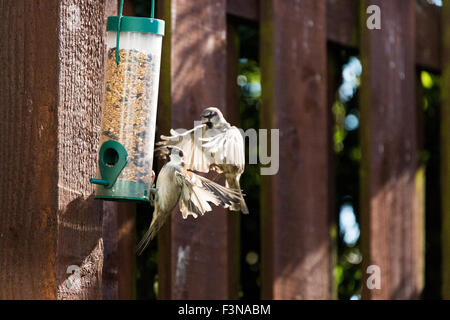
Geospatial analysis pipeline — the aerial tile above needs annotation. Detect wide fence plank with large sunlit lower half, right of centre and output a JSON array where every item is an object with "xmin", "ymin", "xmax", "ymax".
[{"xmin": 361, "ymin": 0, "xmax": 424, "ymax": 299}]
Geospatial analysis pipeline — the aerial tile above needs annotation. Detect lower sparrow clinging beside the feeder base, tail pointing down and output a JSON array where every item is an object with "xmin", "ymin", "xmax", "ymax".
[{"xmin": 137, "ymin": 147, "xmax": 241, "ymax": 254}]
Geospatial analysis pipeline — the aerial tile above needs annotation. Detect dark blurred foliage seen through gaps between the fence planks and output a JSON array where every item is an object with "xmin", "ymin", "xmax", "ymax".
[{"xmin": 133, "ymin": 0, "xmax": 442, "ymax": 300}]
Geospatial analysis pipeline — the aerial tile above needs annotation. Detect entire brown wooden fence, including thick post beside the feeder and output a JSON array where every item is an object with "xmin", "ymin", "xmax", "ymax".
[{"xmin": 0, "ymin": 0, "xmax": 450, "ymax": 299}]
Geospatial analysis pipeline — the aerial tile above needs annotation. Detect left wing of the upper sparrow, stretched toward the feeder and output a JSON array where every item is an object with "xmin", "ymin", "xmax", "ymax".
[{"xmin": 157, "ymin": 124, "xmax": 214, "ymax": 172}]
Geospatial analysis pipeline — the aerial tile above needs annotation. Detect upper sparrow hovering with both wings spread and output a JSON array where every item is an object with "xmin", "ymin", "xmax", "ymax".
[{"xmin": 158, "ymin": 107, "xmax": 248, "ymax": 214}]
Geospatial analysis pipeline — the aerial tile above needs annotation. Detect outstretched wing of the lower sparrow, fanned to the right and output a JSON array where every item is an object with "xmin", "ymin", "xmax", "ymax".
[{"xmin": 176, "ymin": 171, "xmax": 241, "ymax": 219}]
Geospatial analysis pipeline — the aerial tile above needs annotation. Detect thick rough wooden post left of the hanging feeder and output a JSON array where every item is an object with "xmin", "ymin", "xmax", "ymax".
[{"xmin": 0, "ymin": 0, "xmax": 122, "ymax": 299}]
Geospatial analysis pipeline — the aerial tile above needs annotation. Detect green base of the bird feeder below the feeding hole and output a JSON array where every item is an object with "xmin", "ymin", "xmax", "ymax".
[{"xmin": 95, "ymin": 180, "xmax": 150, "ymax": 202}]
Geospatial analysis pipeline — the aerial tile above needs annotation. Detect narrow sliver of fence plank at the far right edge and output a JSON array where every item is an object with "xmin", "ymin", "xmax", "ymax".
[{"xmin": 441, "ymin": 1, "xmax": 450, "ymax": 299}]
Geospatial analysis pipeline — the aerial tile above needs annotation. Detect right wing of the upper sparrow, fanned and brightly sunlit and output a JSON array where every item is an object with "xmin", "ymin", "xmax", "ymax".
[{"xmin": 200, "ymin": 127, "xmax": 245, "ymax": 172}]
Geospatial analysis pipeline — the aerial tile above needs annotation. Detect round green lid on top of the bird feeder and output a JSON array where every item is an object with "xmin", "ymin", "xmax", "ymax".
[{"xmin": 106, "ymin": 16, "xmax": 164, "ymax": 36}]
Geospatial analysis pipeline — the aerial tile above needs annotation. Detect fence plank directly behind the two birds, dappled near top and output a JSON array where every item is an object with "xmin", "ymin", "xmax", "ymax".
[{"xmin": 158, "ymin": 0, "xmax": 236, "ymax": 299}]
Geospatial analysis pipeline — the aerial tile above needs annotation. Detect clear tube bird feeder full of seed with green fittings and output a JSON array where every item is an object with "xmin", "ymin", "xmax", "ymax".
[{"xmin": 91, "ymin": 0, "xmax": 164, "ymax": 201}]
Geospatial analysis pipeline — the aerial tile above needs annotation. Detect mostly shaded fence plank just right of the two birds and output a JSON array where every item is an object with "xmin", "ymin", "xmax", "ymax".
[{"xmin": 260, "ymin": 0, "xmax": 333, "ymax": 299}]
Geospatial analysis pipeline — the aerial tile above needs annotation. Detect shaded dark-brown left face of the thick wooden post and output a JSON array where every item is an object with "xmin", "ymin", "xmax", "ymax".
[{"xmin": 0, "ymin": 0, "xmax": 59, "ymax": 299}]
